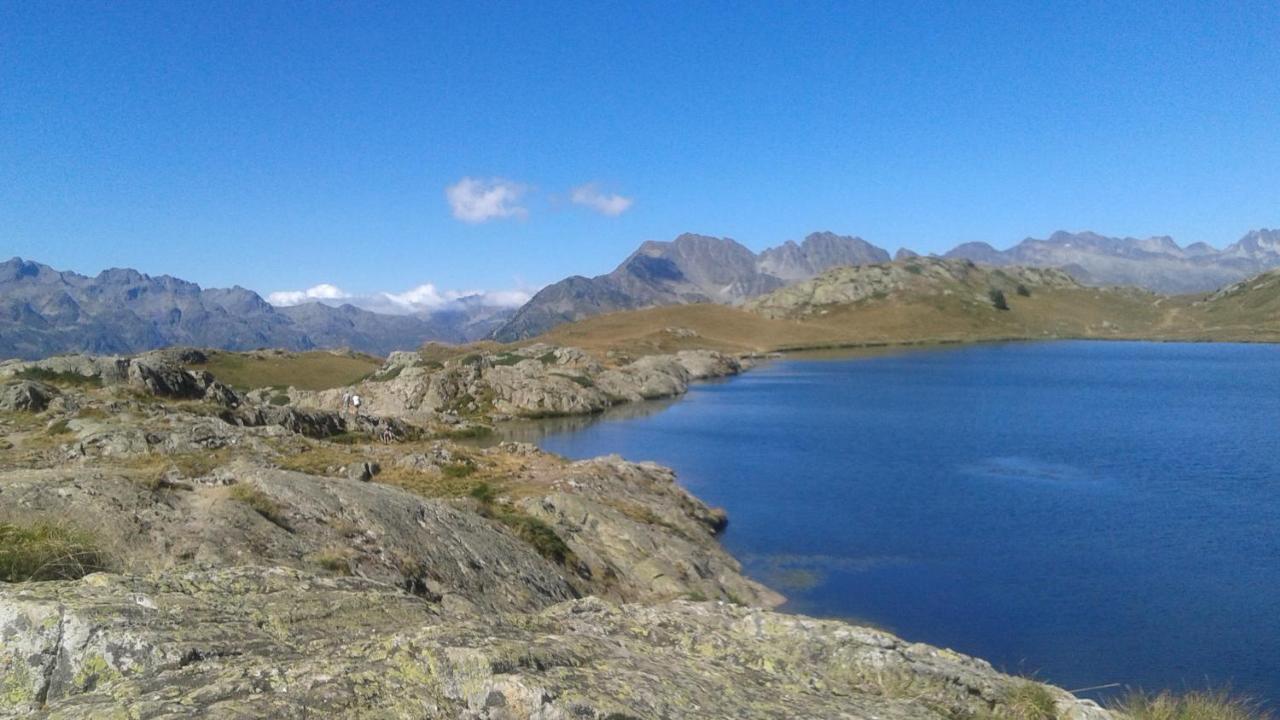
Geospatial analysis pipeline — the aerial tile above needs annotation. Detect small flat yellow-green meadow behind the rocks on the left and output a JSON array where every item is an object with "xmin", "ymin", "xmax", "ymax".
[{"xmin": 194, "ymin": 350, "xmax": 383, "ymax": 389}]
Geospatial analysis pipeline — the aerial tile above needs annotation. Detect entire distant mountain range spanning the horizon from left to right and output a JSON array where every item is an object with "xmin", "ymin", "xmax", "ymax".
[{"xmin": 0, "ymin": 229, "xmax": 1280, "ymax": 359}]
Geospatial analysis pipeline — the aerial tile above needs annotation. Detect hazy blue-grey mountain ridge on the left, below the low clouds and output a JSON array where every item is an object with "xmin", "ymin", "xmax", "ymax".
[{"xmin": 0, "ymin": 258, "xmax": 509, "ymax": 357}]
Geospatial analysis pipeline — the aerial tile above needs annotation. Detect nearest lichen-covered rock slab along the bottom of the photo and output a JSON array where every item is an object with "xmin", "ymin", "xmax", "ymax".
[{"xmin": 0, "ymin": 568, "xmax": 1108, "ymax": 720}]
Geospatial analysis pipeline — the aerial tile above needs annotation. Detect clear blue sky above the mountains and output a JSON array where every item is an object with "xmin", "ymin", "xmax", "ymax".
[{"xmin": 0, "ymin": 0, "xmax": 1280, "ymax": 302}]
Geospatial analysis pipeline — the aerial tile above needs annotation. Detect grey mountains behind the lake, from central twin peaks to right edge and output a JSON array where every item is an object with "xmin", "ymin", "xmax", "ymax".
[{"xmin": 494, "ymin": 229, "xmax": 1280, "ymax": 342}]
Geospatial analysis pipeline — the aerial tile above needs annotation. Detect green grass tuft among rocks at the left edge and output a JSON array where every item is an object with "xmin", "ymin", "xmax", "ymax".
[{"xmin": 0, "ymin": 520, "xmax": 108, "ymax": 583}]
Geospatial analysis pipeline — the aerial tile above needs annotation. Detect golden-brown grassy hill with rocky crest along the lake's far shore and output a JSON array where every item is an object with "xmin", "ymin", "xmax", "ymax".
[{"xmin": 539, "ymin": 260, "xmax": 1192, "ymax": 354}]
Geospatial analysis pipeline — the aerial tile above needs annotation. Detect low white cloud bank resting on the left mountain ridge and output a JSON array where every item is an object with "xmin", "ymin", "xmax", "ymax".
[{"xmin": 266, "ymin": 283, "xmax": 535, "ymax": 315}]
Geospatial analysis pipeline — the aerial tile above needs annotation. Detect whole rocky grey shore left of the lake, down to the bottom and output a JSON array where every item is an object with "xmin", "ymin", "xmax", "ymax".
[{"xmin": 0, "ymin": 346, "xmax": 1107, "ymax": 720}]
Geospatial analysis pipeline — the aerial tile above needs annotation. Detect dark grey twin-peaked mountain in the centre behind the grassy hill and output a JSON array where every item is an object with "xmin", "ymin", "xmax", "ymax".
[{"xmin": 494, "ymin": 232, "xmax": 890, "ymax": 341}]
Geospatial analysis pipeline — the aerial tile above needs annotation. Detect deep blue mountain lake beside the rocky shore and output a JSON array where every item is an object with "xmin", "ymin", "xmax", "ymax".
[{"xmin": 514, "ymin": 342, "xmax": 1280, "ymax": 702}]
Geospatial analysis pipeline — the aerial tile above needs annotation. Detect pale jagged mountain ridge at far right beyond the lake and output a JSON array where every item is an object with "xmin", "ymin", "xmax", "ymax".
[{"xmin": 943, "ymin": 229, "xmax": 1280, "ymax": 288}]
